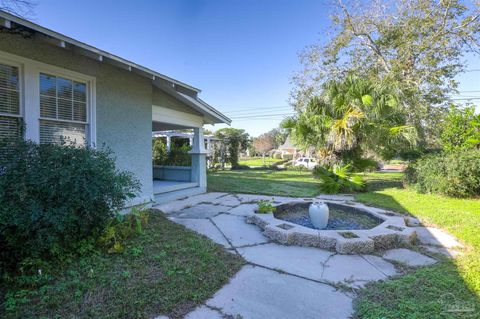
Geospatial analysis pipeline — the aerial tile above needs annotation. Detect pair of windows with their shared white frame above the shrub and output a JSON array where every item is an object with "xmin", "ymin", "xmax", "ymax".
[{"xmin": 0, "ymin": 51, "xmax": 97, "ymax": 146}]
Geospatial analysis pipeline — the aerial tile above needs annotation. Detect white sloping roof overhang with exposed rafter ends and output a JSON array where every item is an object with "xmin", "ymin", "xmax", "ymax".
[{"xmin": 0, "ymin": 10, "xmax": 231, "ymax": 124}]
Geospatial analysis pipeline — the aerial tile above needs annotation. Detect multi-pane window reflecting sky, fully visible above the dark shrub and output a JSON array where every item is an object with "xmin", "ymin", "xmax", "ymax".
[{"xmin": 40, "ymin": 73, "xmax": 88, "ymax": 145}]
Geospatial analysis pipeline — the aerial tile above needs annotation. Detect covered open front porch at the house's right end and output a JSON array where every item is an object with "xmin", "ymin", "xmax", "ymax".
[{"xmin": 152, "ymin": 85, "xmax": 230, "ymax": 203}]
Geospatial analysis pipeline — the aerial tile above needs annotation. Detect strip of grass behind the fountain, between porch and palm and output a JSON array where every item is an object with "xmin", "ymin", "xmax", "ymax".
[{"xmin": 208, "ymin": 170, "xmax": 320, "ymax": 197}]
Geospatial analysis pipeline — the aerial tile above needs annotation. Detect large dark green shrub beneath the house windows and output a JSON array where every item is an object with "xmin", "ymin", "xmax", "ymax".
[{"xmin": 0, "ymin": 140, "xmax": 139, "ymax": 270}]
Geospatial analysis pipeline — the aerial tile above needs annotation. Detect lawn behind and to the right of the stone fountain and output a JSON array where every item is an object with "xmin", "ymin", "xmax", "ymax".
[{"xmin": 209, "ymin": 170, "xmax": 480, "ymax": 319}]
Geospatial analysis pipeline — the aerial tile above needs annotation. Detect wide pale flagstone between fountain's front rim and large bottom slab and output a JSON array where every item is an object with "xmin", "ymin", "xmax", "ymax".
[{"xmin": 237, "ymin": 243, "xmax": 333, "ymax": 280}]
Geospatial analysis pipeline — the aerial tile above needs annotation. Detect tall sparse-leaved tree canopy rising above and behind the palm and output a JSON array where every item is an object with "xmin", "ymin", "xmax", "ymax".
[{"xmin": 291, "ymin": 0, "xmax": 480, "ymax": 143}]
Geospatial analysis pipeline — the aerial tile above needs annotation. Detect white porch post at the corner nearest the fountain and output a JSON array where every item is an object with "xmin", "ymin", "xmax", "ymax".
[{"xmin": 189, "ymin": 127, "xmax": 207, "ymax": 190}]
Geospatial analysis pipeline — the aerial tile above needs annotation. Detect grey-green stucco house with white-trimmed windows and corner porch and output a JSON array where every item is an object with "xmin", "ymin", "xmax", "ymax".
[{"xmin": 0, "ymin": 11, "xmax": 230, "ymax": 205}]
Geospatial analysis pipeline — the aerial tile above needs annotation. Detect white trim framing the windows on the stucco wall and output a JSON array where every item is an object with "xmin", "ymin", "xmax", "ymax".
[{"xmin": 0, "ymin": 51, "xmax": 97, "ymax": 147}]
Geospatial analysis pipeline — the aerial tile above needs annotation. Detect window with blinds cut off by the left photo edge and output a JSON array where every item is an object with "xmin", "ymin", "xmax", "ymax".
[{"xmin": 0, "ymin": 63, "xmax": 23, "ymax": 138}]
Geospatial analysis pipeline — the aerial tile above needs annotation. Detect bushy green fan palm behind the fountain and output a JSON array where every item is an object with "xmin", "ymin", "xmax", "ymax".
[{"xmin": 282, "ymin": 76, "xmax": 416, "ymax": 164}]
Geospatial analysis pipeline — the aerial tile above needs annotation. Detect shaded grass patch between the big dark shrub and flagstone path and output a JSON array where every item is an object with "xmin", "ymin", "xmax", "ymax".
[{"xmin": 0, "ymin": 212, "xmax": 243, "ymax": 318}]
